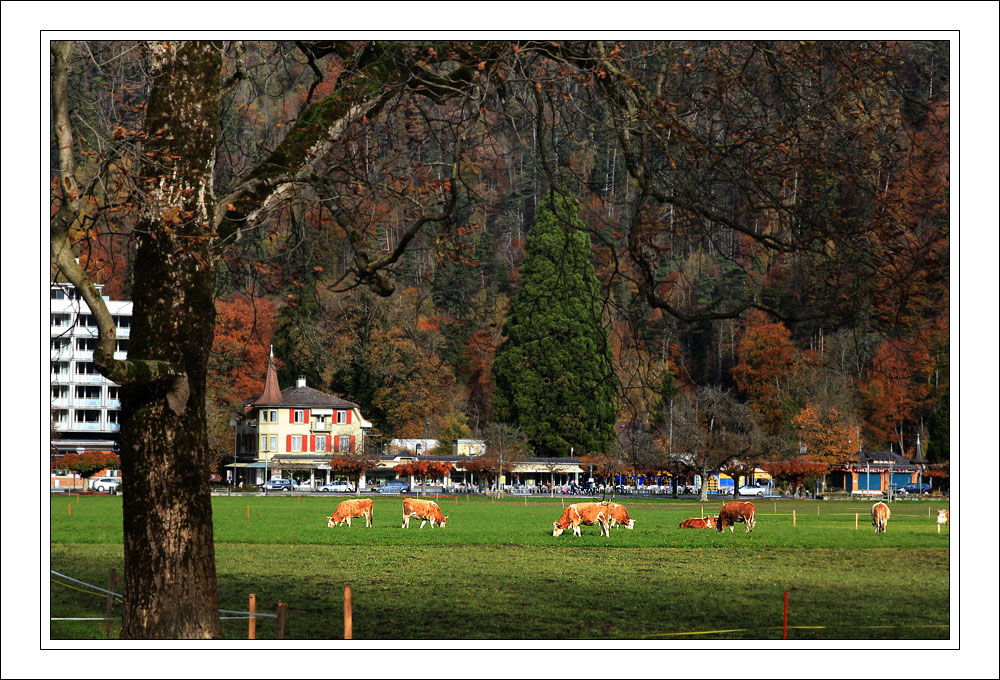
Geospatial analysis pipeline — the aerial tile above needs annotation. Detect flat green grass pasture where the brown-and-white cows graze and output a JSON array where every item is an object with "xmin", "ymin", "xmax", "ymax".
[{"xmin": 51, "ymin": 495, "xmax": 950, "ymax": 640}]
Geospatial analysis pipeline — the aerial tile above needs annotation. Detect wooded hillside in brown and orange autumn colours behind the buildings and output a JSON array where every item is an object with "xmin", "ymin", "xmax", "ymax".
[{"xmin": 58, "ymin": 41, "xmax": 950, "ymax": 468}]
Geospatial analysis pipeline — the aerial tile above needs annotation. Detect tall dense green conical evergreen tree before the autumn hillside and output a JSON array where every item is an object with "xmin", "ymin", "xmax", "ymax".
[{"xmin": 493, "ymin": 192, "xmax": 616, "ymax": 457}]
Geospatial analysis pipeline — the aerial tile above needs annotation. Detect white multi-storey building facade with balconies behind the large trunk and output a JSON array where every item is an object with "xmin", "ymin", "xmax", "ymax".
[{"xmin": 49, "ymin": 283, "xmax": 132, "ymax": 437}]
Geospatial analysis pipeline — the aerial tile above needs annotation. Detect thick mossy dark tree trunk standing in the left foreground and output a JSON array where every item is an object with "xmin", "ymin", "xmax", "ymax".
[{"xmin": 121, "ymin": 41, "xmax": 221, "ymax": 639}]
